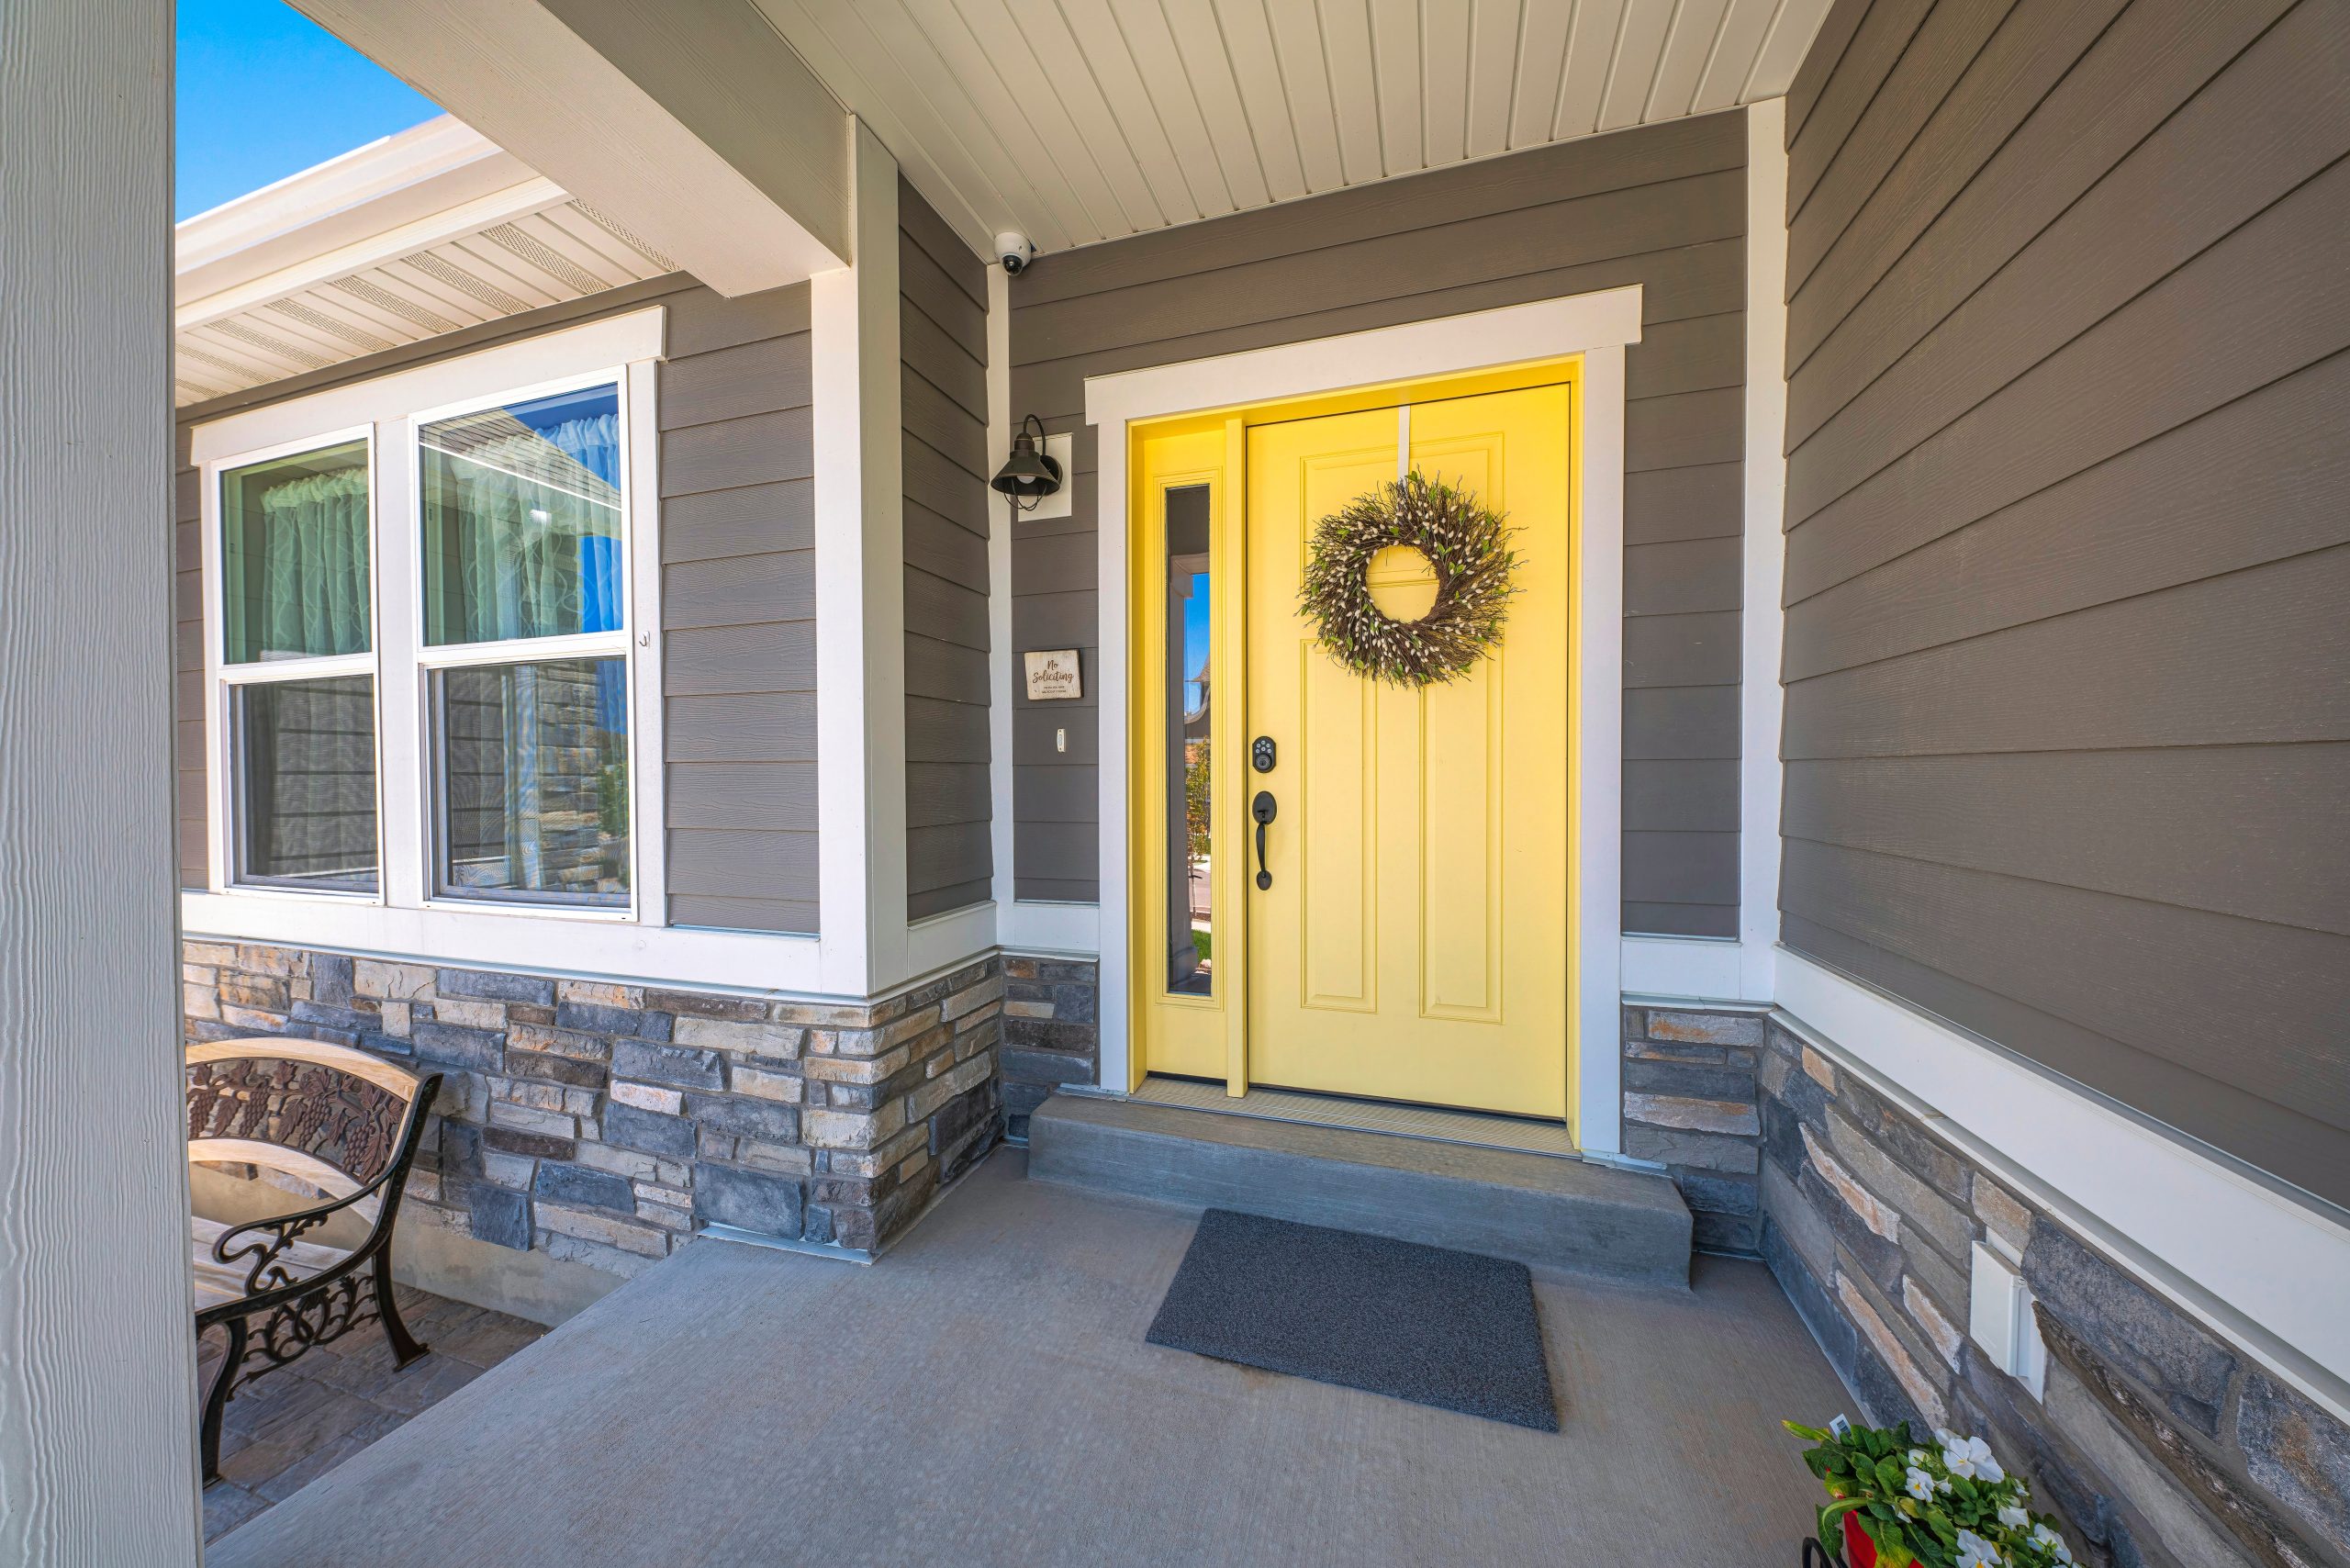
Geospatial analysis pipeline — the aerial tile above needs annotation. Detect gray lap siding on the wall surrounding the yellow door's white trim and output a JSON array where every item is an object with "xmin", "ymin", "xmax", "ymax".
[{"xmin": 1013, "ymin": 113, "xmax": 1746, "ymax": 935}]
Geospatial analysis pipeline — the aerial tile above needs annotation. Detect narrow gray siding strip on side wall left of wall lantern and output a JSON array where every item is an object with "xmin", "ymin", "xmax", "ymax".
[{"xmin": 898, "ymin": 179, "xmax": 994, "ymax": 919}]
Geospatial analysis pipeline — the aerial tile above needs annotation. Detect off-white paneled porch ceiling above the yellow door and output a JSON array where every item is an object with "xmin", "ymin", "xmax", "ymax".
[{"xmin": 756, "ymin": 0, "xmax": 1830, "ymax": 254}]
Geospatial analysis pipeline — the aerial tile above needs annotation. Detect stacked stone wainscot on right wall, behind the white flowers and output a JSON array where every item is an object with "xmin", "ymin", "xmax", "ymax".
[{"xmin": 1758, "ymin": 1018, "xmax": 2350, "ymax": 1568}]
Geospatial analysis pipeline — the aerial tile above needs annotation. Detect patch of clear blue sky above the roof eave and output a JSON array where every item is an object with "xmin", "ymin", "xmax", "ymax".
[{"xmin": 172, "ymin": 0, "xmax": 440, "ymax": 218}]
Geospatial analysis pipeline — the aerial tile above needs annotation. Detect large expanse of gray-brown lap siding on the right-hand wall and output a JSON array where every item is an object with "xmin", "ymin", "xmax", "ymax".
[{"xmin": 1781, "ymin": 0, "xmax": 2350, "ymax": 1204}]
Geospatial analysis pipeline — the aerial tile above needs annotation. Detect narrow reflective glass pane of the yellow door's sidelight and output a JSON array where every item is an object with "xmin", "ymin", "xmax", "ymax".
[{"xmin": 1163, "ymin": 485, "xmax": 1215, "ymax": 997}]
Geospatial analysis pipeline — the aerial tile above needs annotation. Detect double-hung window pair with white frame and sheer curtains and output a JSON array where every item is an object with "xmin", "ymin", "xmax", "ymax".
[{"xmin": 197, "ymin": 324, "xmax": 658, "ymax": 922}]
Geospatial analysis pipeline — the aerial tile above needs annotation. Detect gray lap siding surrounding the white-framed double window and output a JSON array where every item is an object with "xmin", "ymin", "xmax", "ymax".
[{"xmin": 173, "ymin": 277, "xmax": 818, "ymax": 934}]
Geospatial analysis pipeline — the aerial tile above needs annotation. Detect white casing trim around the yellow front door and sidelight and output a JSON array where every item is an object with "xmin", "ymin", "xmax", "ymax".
[{"xmin": 1086, "ymin": 286, "xmax": 1640, "ymax": 1154}]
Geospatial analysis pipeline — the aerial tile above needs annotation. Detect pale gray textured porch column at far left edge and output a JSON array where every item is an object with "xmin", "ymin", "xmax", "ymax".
[{"xmin": 0, "ymin": 0, "xmax": 202, "ymax": 1563}]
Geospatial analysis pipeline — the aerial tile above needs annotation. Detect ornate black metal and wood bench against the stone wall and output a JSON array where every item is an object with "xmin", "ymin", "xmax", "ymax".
[{"xmin": 188, "ymin": 1036, "xmax": 440, "ymax": 1484}]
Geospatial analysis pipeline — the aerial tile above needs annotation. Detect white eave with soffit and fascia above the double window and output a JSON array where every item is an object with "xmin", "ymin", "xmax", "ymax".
[{"xmin": 172, "ymin": 115, "xmax": 677, "ymax": 407}]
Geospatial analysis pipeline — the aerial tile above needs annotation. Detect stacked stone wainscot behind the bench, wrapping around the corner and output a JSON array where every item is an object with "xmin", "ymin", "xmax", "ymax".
[{"xmin": 181, "ymin": 940, "xmax": 1003, "ymax": 1274}]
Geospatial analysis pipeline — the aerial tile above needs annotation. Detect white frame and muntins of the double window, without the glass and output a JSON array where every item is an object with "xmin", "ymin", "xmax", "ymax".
[{"xmin": 193, "ymin": 308, "xmax": 667, "ymax": 928}]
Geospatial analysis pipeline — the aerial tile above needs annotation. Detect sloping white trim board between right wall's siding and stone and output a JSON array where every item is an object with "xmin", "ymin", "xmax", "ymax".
[{"xmin": 1776, "ymin": 947, "xmax": 2350, "ymax": 1420}]
